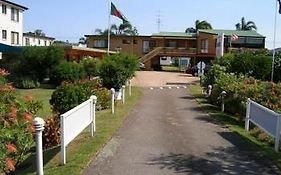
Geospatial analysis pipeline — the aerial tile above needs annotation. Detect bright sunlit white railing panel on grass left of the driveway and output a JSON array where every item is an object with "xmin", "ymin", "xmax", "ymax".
[{"xmin": 60, "ymin": 96, "xmax": 97, "ymax": 165}]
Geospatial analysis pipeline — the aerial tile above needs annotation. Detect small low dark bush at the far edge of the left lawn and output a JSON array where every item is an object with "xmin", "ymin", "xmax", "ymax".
[{"xmin": 14, "ymin": 77, "xmax": 40, "ymax": 89}]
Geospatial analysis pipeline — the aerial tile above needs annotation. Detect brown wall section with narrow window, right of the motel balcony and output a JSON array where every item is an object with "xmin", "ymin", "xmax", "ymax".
[{"xmin": 197, "ymin": 33, "xmax": 216, "ymax": 57}]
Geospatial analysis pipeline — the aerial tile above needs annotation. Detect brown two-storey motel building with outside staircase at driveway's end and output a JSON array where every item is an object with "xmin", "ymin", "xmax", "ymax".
[{"xmin": 85, "ymin": 30, "xmax": 265, "ymax": 70}]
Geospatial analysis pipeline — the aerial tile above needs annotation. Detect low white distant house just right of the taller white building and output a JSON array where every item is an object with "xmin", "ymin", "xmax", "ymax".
[{"xmin": 23, "ymin": 32, "xmax": 55, "ymax": 46}]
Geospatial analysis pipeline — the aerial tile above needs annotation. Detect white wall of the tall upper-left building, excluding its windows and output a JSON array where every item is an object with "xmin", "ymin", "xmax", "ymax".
[{"xmin": 0, "ymin": 1, "xmax": 23, "ymax": 46}]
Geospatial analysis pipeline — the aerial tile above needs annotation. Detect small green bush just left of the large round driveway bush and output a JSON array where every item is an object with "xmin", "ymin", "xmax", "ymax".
[{"xmin": 82, "ymin": 58, "xmax": 100, "ymax": 77}]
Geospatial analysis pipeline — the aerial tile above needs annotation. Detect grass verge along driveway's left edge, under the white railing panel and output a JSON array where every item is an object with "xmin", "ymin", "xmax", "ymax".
[{"xmin": 16, "ymin": 87, "xmax": 142, "ymax": 175}]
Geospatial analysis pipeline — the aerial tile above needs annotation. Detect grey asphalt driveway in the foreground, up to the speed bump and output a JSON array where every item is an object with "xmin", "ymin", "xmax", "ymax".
[{"xmin": 83, "ymin": 87, "xmax": 280, "ymax": 175}]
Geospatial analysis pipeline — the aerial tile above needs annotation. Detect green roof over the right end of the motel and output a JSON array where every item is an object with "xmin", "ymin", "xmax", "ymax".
[{"xmin": 198, "ymin": 29, "xmax": 265, "ymax": 38}]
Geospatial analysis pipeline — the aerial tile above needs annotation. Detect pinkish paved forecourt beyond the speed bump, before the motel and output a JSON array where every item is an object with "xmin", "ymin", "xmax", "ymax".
[{"xmin": 132, "ymin": 71, "xmax": 199, "ymax": 87}]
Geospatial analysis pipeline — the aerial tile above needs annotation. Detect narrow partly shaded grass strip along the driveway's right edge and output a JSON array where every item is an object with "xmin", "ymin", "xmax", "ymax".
[{"xmin": 189, "ymin": 85, "xmax": 281, "ymax": 169}]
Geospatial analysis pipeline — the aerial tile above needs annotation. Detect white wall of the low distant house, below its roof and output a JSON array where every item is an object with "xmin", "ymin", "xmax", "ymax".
[{"xmin": 22, "ymin": 36, "xmax": 54, "ymax": 46}]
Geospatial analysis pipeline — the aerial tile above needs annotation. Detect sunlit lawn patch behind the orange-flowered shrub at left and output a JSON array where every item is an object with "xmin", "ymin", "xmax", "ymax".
[{"xmin": 16, "ymin": 88, "xmax": 54, "ymax": 118}]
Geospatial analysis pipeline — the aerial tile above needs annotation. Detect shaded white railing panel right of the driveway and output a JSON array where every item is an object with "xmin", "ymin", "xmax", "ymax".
[{"xmin": 245, "ymin": 99, "xmax": 281, "ymax": 151}]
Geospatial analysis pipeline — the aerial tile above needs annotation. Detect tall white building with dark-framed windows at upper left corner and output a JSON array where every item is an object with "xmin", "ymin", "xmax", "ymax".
[{"xmin": 0, "ymin": 0, "xmax": 27, "ymax": 46}]
